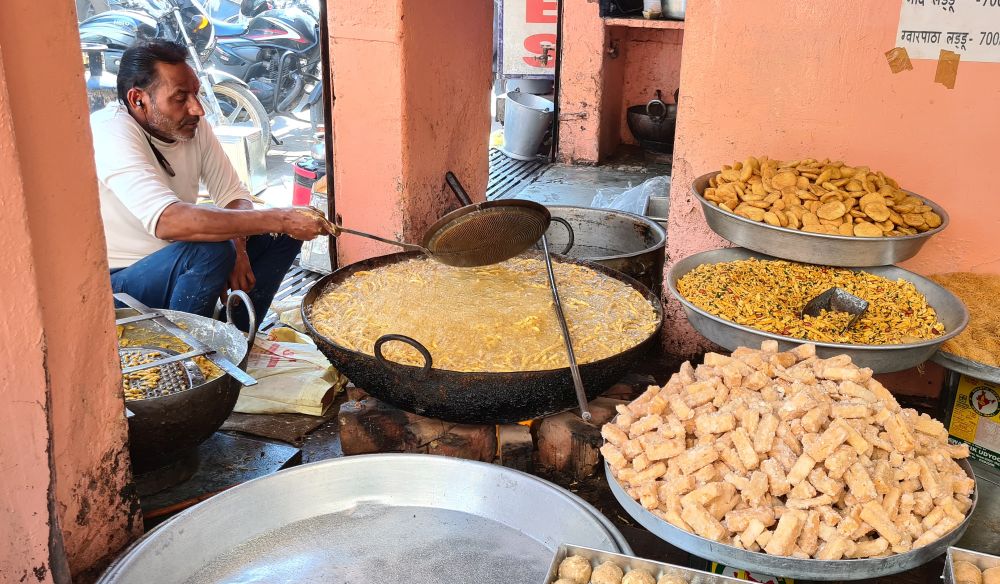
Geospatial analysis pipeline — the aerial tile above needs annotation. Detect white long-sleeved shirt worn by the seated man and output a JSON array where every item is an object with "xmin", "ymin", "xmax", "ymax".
[{"xmin": 90, "ymin": 103, "xmax": 250, "ymax": 268}]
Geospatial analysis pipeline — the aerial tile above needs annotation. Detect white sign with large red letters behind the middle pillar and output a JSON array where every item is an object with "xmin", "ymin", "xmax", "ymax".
[{"xmin": 504, "ymin": 0, "xmax": 559, "ymax": 77}]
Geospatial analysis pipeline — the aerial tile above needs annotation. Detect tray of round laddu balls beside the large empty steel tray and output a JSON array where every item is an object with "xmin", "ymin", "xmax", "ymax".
[{"xmin": 544, "ymin": 545, "xmax": 743, "ymax": 584}]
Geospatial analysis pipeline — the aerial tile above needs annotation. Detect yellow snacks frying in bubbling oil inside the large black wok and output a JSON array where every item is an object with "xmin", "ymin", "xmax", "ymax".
[{"xmin": 309, "ymin": 257, "xmax": 658, "ymax": 372}]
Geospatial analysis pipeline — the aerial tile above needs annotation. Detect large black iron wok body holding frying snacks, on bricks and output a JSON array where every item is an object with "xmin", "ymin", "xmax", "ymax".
[{"xmin": 302, "ymin": 252, "xmax": 663, "ymax": 424}]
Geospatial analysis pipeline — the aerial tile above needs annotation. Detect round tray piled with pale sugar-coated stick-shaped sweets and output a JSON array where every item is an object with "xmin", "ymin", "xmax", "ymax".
[{"xmin": 601, "ymin": 341, "xmax": 977, "ymax": 580}]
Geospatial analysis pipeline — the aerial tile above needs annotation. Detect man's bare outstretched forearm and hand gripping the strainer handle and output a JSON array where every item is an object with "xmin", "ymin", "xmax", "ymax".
[{"xmin": 156, "ymin": 202, "xmax": 325, "ymax": 241}]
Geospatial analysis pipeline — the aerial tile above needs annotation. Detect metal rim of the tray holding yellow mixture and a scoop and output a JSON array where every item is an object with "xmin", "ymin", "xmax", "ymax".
[{"xmin": 664, "ymin": 247, "xmax": 969, "ymax": 351}]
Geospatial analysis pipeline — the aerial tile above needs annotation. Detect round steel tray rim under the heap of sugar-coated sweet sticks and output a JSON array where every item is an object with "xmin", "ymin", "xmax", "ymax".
[{"xmin": 604, "ymin": 460, "xmax": 979, "ymax": 581}]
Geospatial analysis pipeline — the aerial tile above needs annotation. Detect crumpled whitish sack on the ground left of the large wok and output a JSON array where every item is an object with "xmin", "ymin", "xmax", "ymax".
[{"xmin": 233, "ymin": 328, "xmax": 347, "ymax": 416}]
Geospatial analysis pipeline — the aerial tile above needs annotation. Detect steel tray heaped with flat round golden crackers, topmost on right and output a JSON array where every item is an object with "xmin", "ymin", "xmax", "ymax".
[{"xmin": 691, "ymin": 156, "xmax": 948, "ymax": 266}]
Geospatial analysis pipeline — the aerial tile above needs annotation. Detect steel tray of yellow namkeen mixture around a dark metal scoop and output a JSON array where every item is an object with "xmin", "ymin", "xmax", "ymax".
[{"xmin": 667, "ymin": 248, "xmax": 969, "ymax": 373}]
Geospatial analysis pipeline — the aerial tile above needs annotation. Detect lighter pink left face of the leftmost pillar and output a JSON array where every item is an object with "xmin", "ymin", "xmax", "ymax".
[{"xmin": 0, "ymin": 52, "xmax": 59, "ymax": 582}]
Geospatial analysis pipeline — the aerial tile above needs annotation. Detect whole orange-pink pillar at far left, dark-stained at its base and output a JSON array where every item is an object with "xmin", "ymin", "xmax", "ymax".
[{"xmin": 0, "ymin": 0, "xmax": 142, "ymax": 582}]
